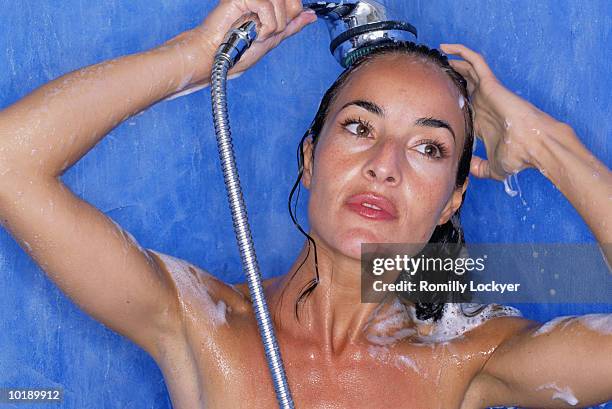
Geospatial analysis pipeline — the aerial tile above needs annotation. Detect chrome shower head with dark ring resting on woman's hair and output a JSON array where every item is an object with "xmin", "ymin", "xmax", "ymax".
[{"xmin": 304, "ymin": 0, "xmax": 417, "ymax": 68}]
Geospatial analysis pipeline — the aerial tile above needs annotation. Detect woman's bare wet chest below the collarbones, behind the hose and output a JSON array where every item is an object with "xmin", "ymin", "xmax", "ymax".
[{"xmin": 160, "ymin": 322, "xmax": 473, "ymax": 409}]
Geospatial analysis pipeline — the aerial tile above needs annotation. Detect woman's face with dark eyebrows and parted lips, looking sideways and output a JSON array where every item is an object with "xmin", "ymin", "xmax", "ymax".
[{"xmin": 303, "ymin": 54, "xmax": 467, "ymax": 259}]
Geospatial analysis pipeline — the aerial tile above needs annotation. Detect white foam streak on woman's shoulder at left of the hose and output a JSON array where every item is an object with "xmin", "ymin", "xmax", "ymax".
[{"xmin": 150, "ymin": 250, "xmax": 231, "ymax": 326}]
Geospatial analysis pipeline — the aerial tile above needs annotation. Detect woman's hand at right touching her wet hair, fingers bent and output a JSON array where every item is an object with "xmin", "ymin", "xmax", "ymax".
[{"xmin": 440, "ymin": 44, "xmax": 558, "ymax": 180}]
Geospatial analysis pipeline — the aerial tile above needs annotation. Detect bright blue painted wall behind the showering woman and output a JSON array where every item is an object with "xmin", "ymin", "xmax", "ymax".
[{"xmin": 0, "ymin": 0, "xmax": 612, "ymax": 409}]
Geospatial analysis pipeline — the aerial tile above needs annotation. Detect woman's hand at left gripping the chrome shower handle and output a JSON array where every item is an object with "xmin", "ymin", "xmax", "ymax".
[{"xmin": 194, "ymin": 0, "xmax": 317, "ymax": 74}]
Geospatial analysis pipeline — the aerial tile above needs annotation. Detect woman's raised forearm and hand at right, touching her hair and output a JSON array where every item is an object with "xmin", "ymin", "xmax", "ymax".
[{"xmin": 441, "ymin": 44, "xmax": 612, "ymax": 264}]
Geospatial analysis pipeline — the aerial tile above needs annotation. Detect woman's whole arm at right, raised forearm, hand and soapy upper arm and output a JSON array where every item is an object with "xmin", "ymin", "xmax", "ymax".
[{"xmin": 442, "ymin": 44, "xmax": 612, "ymax": 408}]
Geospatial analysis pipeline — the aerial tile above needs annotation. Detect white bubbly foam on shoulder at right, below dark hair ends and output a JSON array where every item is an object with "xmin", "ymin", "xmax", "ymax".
[{"xmin": 409, "ymin": 303, "xmax": 522, "ymax": 342}]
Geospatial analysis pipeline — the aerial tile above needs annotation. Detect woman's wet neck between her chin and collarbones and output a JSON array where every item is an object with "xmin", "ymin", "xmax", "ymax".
[{"xmin": 266, "ymin": 233, "xmax": 413, "ymax": 355}]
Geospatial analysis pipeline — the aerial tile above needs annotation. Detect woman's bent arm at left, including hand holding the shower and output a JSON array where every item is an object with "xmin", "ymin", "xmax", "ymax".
[{"xmin": 0, "ymin": 0, "xmax": 314, "ymax": 356}]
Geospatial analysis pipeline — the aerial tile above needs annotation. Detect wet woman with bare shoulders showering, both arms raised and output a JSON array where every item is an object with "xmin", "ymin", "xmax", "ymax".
[{"xmin": 0, "ymin": 0, "xmax": 612, "ymax": 409}]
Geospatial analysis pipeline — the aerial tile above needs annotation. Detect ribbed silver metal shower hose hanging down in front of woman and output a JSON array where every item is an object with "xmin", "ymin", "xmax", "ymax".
[{"xmin": 210, "ymin": 21, "xmax": 294, "ymax": 409}]
